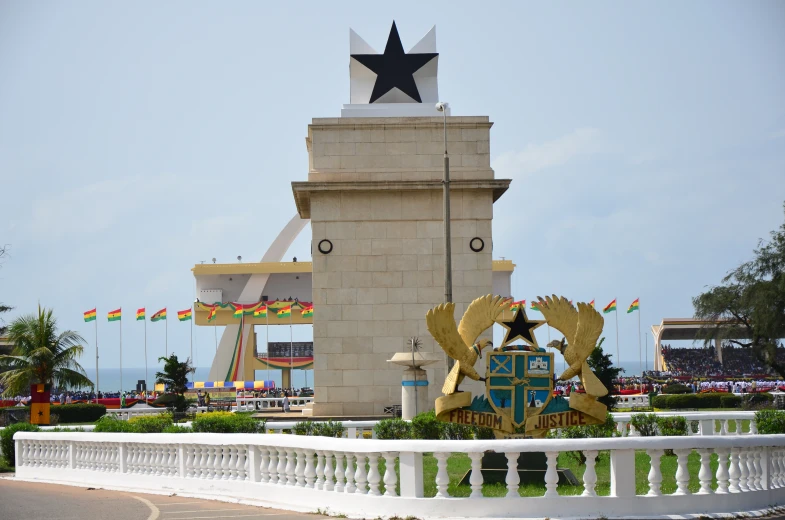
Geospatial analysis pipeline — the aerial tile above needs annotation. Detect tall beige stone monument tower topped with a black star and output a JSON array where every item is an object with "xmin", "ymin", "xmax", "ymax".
[{"xmin": 292, "ymin": 23, "xmax": 510, "ymax": 416}]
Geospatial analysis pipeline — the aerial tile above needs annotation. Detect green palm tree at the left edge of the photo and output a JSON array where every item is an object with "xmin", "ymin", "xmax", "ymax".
[{"xmin": 0, "ymin": 305, "xmax": 93, "ymax": 395}]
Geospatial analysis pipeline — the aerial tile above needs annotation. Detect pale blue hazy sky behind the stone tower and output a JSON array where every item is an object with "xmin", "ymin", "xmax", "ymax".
[{"xmin": 0, "ymin": 0, "xmax": 785, "ymax": 374}]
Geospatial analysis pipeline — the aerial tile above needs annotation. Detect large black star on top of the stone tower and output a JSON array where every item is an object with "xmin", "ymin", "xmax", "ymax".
[{"xmin": 351, "ymin": 22, "xmax": 439, "ymax": 103}]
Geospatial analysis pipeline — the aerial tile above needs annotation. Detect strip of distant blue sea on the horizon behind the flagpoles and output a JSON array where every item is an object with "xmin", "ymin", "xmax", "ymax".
[{"xmin": 78, "ymin": 356, "xmax": 652, "ymax": 392}]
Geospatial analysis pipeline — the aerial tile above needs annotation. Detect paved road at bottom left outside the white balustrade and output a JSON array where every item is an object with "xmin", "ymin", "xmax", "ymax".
[{"xmin": 0, "ymin": 478, "xmax": 328, "ymax": 520}]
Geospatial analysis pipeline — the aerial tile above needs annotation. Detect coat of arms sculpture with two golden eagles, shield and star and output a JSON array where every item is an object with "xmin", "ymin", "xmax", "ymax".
[{"xmin": 426, "ymin": 295, "xmax": 608, "ymax": 437}]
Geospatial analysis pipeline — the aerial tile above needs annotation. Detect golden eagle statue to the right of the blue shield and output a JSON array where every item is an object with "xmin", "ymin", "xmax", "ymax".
[{"xmin": 537, "ymin": 294, "xmax": 608, "ymax": 397}]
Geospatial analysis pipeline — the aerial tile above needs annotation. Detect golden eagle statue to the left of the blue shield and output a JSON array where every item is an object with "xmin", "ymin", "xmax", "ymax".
[{"xmin": 425, "ymin": 295, "xmax": 509, "ymax": 395}]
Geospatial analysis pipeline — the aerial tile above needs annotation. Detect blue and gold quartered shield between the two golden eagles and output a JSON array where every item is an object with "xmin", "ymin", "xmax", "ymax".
[{"xmin": 485, "ymin": 350, "xmax": 553, "ymax": 428}]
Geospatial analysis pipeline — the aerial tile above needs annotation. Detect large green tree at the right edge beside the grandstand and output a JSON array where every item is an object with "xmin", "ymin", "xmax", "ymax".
[{"xmin": 692, "ymin": 205, "xmax": 785, "ymax": 377}]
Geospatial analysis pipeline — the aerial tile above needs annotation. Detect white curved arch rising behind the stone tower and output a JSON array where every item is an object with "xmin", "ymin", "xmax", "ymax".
[{"xmin": 209, "ymin": 214, "xmax": 309, "ymax": 381}]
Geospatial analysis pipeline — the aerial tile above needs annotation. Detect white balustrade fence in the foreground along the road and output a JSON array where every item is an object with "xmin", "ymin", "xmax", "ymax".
[{"xmin": 14, "ymin": 432, "xmax": 785, "ymax": 518}]
